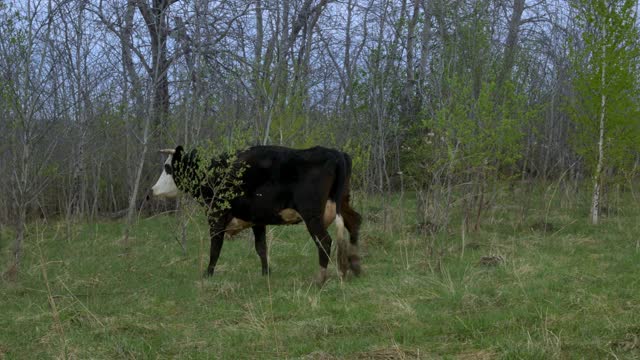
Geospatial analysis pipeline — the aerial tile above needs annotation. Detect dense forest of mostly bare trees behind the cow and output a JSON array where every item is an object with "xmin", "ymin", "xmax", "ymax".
[{"xmin": 0, "ymin": 0, "xmax": 640, "ymax": 271}]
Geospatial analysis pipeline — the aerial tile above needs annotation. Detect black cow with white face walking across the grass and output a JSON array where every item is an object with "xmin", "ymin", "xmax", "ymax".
[{"xmin": 152, "ymin": 146, "xmax": 361, "ymax": 283}]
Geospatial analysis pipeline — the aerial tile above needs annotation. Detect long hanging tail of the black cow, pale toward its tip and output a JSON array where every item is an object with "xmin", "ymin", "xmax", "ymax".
[{"xmin": 332, "ymin": 153, "xmax": 351, "ymax": 276}]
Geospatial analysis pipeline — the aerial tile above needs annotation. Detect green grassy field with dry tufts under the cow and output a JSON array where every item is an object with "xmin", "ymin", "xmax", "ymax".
[{"xmin": 0, "ymin": 188, "xmax": 640, "ymax": 359}]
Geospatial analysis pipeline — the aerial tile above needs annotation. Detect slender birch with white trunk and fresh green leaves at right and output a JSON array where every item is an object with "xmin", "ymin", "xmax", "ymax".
[{"xmin": 572, "ymin": 0, "xmax": 640, "ymax": 224}]
